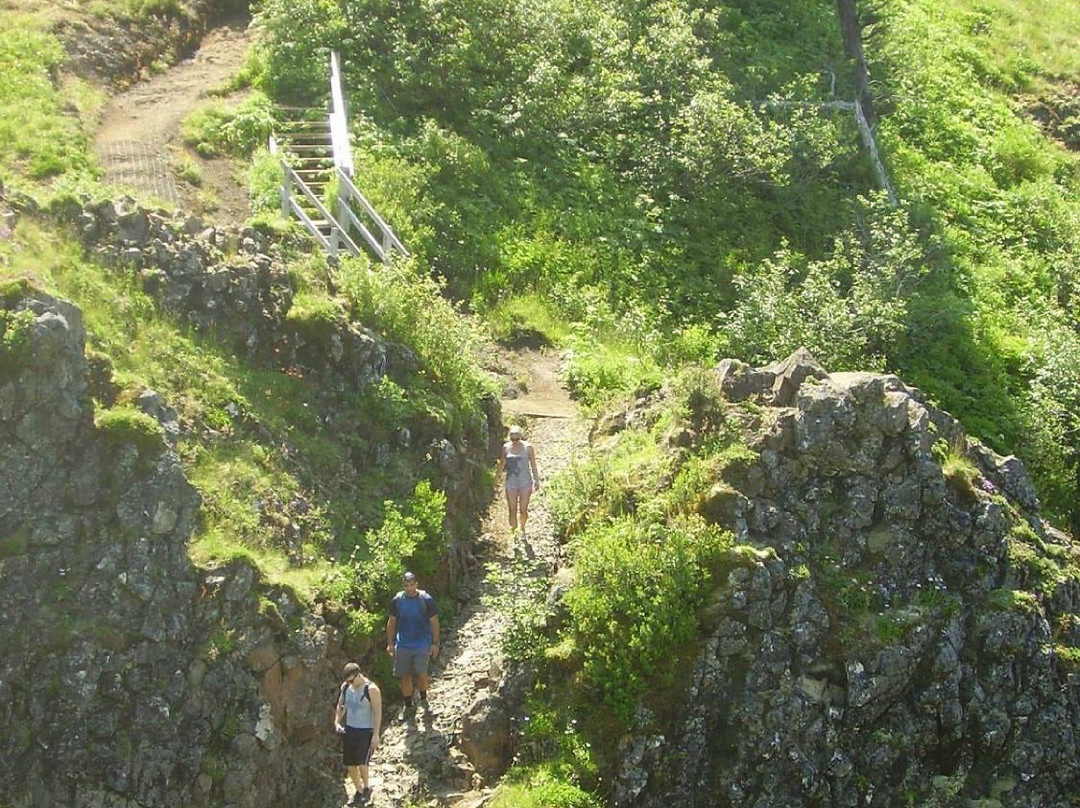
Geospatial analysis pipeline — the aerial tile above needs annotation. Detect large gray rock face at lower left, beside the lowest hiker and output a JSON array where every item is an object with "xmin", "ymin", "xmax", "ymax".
[{"xmin": 0, "ymin": 293, "xmax": 341, "ymax": 808}]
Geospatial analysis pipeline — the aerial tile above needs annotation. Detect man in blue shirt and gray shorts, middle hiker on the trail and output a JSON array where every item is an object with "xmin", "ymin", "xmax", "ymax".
[{"xmin": 387, "ymin": 573, "xmax": 438, "ymax": 716}]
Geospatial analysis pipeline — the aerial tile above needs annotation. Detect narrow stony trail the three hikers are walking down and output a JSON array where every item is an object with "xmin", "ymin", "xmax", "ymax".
[{"xmin": 360, "ymin": 352, "xmax": 588, "ymax": 808}]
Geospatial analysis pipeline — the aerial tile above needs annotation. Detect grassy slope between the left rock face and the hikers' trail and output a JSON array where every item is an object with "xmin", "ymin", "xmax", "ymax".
[{"xmin": 0, "ymin": 2, "xmax": 489, "ymax": 628}]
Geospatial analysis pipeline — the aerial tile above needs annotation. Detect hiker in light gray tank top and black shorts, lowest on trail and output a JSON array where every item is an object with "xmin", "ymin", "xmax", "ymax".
[{"xmin": 334, "ymin": 662, "xmax": 382, "ymax": 806}]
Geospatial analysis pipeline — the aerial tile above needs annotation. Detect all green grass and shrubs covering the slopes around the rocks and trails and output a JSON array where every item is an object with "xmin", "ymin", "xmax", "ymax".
[{"xmin": 0, "ymin": 0, "xmax": 1080, "ymax": 807}]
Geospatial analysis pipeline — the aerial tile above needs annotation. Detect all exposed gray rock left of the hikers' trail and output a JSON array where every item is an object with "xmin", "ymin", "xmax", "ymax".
[{"xmin": 0, "ymin": 184, "xmax": 498, "ymax": 808}]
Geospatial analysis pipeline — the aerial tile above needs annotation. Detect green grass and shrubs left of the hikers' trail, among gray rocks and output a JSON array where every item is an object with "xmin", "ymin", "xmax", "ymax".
[{"xmin": 0, "ymin": 2, "xmax": 495, "ymax": 647}]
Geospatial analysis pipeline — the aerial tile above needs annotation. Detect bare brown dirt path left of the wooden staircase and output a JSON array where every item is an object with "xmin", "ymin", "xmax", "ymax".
[{"xmin": 94, "ymin": 17, "xmax": 251, "ymax": 224}]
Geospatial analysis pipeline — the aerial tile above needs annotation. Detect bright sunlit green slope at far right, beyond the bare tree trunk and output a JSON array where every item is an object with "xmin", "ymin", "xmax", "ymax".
[{"xmin": 870, "ymin": 0, "xmax": 1080, "ymax": 521}]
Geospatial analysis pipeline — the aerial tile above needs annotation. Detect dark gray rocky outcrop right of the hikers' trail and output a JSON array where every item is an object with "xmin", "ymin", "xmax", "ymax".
[{"xmin": 615, "ymin": 354, "xmax": 1080, "ymax": 808}]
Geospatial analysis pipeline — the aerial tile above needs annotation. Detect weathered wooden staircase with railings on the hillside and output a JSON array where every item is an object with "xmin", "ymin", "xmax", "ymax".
[{"xmin": 270, "ymin": 53, "xmax": 409, "ymax": 262}]
